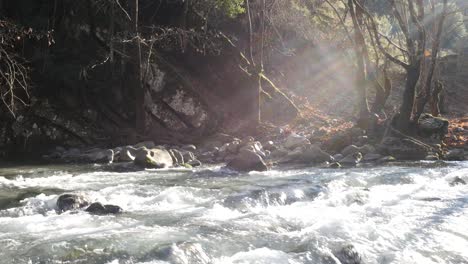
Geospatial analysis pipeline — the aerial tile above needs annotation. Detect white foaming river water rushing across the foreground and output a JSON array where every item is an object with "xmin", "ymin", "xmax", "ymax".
[{"xmin": 0, "ymin": 162, "xmax": 468, "ymax": 264}]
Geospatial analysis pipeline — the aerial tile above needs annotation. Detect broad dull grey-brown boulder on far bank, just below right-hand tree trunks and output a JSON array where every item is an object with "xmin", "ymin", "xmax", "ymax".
[{"xmin": 378, "ymin": 137, "xmax": 431, "ymax": 160}]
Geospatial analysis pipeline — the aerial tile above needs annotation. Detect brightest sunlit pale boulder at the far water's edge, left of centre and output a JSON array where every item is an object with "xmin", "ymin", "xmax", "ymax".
[{"xmin": 134, "ymin": 148, "xmax": 174, "ymax": 169}]
